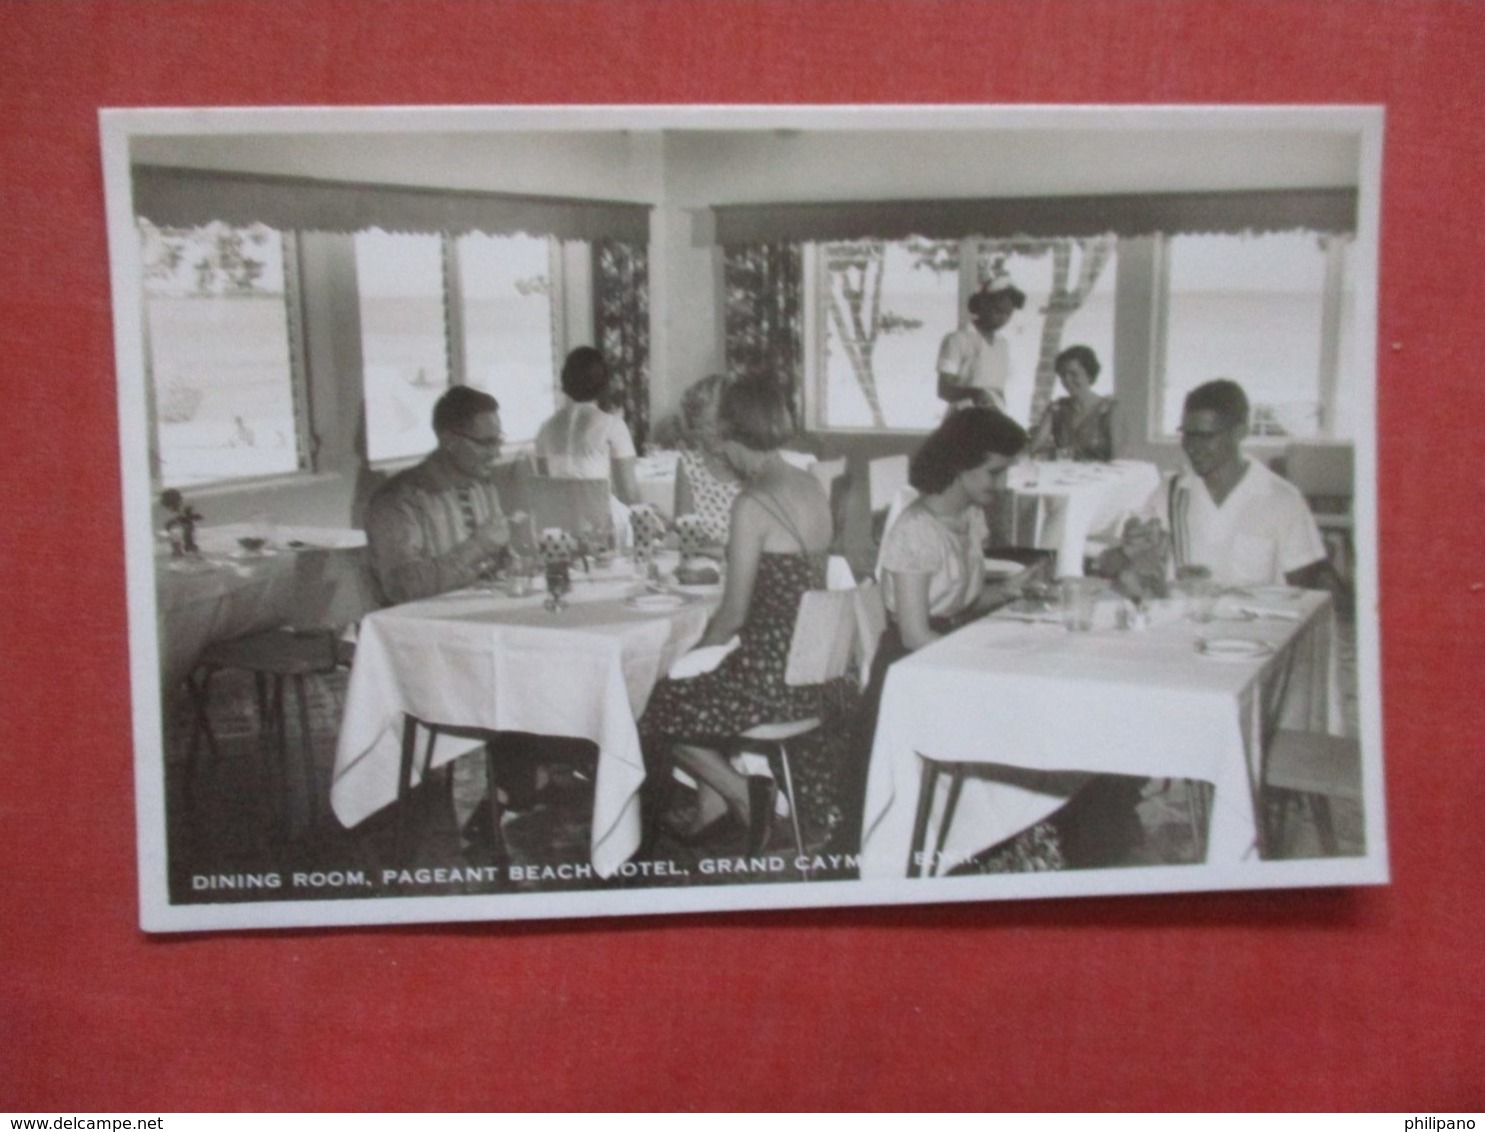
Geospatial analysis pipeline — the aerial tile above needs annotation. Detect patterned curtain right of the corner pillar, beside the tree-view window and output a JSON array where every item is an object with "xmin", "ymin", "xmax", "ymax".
[{"xmin": 723, "ymin": 244, "xmax": 805, "ymax": 426}]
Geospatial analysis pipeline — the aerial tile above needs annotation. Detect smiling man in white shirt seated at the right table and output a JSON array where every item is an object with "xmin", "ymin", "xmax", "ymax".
[{"xmin": 1100, "ymin": 379, "xmax": 1334, "ymax": 588}]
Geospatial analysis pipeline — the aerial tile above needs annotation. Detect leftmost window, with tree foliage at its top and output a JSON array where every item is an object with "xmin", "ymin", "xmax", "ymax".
[{"xmin": 138, "ymin": 220, "xmax": 309, "ymax": 487}]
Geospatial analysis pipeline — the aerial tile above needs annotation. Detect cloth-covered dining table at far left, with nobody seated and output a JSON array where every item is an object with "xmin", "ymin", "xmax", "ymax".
[{"xmin": 154, "ymin": 523, "xmax": 367, "ymax": 689}]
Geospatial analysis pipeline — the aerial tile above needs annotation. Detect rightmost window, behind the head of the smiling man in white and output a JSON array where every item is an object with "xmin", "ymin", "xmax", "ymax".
[{"xmin": 1158, "ymin": 232, "xmax": 1351, "ymax": 437}]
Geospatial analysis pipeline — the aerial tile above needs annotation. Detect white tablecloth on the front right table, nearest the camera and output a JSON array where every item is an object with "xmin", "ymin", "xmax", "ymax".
[{"xmin": 861, "ymin": 591, "xmax": 1341, "ymax": 876}]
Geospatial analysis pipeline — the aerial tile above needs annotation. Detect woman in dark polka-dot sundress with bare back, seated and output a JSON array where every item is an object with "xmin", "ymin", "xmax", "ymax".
[{"xmin": 640, "ymin": 382, "xmax": 833, "ymax": 854}]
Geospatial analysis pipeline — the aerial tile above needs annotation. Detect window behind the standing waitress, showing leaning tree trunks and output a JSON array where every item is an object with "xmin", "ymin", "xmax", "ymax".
[{"xmin": 805, "ymin": 238, "xmax": 1117, "ymax": 429}]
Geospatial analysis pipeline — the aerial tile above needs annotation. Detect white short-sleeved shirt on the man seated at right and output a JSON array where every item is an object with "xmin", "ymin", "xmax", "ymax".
[{"xmin": 1146, "ymin": 461, "xmax": 1325, "ymax": 585}]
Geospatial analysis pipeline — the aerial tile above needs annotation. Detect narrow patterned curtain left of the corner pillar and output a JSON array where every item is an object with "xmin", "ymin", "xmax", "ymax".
[{"xmin": 593, "ymin": 239, "xmax": 649, "ymax": 452}]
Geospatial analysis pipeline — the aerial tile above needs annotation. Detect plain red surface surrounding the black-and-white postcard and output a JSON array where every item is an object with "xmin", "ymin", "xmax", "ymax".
[{"xmin": 0, "ymin": 0, "xmax": 1485, "ymax": 1113}]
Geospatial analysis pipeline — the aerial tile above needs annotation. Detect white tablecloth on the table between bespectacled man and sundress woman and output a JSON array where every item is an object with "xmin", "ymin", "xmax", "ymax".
[{"xmin": 330, "ymin": 575, "xmax": 714, "ymax": 876}]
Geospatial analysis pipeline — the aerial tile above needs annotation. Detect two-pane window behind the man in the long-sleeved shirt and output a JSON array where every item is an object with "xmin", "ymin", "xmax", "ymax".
[{"xmin": 356, "ymin": 232, "xmax": 563, "ymax": 461}]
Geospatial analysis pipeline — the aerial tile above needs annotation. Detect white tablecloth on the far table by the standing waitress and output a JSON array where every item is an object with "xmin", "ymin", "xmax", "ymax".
[{"xmin": 1007, "ymin": 461, "xmax": 1160, "ymax": 576}]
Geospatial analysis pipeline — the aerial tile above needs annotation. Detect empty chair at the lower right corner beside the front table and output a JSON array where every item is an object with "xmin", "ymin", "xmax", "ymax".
[{"xmin": 1264, "ymin": 731, "xmax": 1362, "ymax": 857}]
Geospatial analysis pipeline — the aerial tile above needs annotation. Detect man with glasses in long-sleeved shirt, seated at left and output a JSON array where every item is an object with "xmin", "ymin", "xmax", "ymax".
[{"xmin": 367, "ymin": 385, "xmax": 511, "ymax": 605}]
